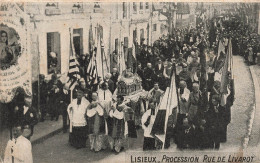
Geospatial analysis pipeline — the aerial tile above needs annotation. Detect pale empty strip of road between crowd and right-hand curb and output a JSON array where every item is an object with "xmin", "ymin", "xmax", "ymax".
[{"xmin": 222, "ymin": 56, "xmax": 255, "ymax": 149}]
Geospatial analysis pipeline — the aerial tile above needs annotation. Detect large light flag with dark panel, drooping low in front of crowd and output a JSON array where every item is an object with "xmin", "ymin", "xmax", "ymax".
[{"xmin": 151, "ymin": 70, "xmax": 178, "ymax": 148}]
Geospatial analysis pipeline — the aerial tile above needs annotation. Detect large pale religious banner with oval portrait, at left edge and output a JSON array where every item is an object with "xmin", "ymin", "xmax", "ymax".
[{"xmin": 0, "ymin": 3, "xmax": 31, "ymax": 103}]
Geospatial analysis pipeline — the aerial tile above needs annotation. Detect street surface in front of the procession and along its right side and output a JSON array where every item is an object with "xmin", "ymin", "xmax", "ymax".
[{"xmin": 33, "ymin": 56, "xmax": 254, "ymax": 163}]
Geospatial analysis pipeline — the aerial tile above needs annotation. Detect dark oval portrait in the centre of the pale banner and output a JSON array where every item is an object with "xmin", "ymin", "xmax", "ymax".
[{"xmin": 0, "ymin": 24, "xmax": 22, "ymax": 70}]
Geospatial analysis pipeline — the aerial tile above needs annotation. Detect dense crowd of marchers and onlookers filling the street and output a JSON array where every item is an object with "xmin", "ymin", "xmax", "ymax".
[{"xmin": 2, "ymin": 10, "xmax": 259, "ymax": 163}]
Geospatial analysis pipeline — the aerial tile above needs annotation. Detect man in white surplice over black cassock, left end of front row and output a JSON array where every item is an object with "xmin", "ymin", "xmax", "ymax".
[{"xmin": 67, "ymin": 89, "xmax": 89, "ymax": 149}]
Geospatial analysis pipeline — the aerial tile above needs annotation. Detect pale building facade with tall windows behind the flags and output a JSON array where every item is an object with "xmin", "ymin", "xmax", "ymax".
[{"xmin": 25, "ymin": 2, "xmax": 173, "ymax": 81}]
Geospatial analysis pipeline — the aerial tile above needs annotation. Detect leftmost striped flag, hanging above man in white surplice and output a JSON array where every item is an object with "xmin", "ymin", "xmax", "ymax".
[{"xmin": 66, "ymin": 28, "xmax": 80, "ymax": 90}]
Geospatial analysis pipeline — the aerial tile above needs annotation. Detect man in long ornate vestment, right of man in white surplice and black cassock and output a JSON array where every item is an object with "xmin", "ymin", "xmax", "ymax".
[{"xmin": 86, "ymin": 92, "xmax": 107, "ymax": 152}]
